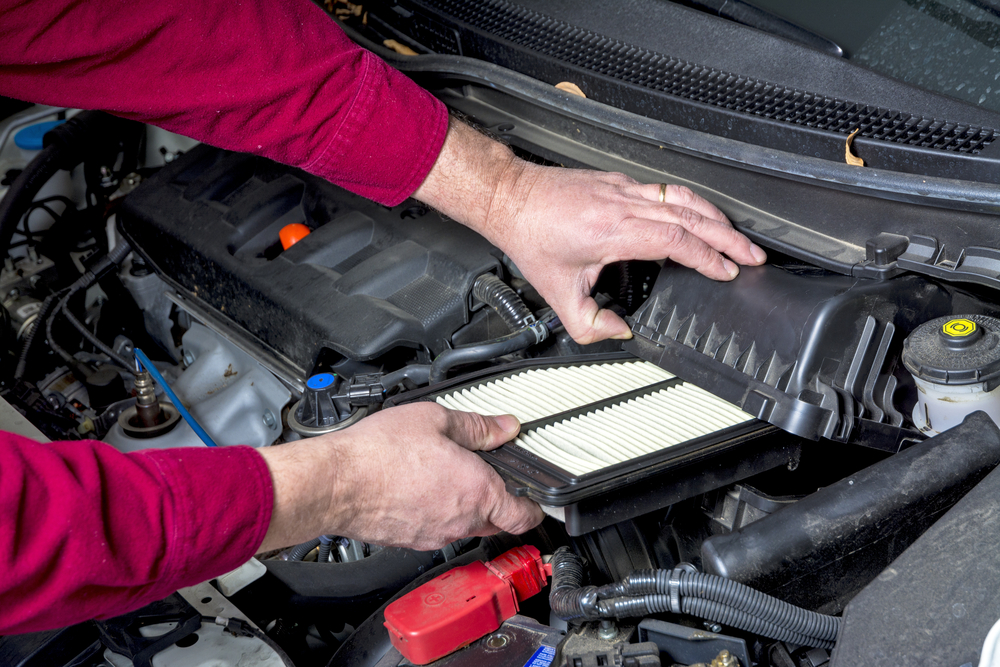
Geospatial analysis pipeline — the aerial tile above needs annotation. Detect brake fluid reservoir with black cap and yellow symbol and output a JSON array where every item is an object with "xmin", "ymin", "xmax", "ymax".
[{"xmin": 903, "ymin": 315, "xmax": 1000, "ymax": 435}]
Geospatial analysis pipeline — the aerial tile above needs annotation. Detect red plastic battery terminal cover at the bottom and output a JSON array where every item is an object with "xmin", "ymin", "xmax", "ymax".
[{"xmin": 385, "ymin": 546, "xmax": 546, "ymax": 665}]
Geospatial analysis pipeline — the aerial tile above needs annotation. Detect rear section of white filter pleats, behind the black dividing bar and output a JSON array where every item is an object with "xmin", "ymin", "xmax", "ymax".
[{"xmin": 436, "ymin": 361, "xmax": 674, "ymax": 423}]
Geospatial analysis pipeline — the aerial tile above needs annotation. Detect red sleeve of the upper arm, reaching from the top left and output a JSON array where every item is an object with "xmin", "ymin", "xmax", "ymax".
[{"xmin": 0, "ymin": 0, "xmax": 448, "ymax": 205}]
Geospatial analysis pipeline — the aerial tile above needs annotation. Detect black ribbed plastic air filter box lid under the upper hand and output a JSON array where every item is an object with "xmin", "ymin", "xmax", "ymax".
[{"xmin": 625, "ymin": 261, "xmax": 982, "ymax": 451}]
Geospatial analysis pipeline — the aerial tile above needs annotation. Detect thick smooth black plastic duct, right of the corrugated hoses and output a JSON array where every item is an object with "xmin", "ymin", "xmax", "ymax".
[{"xmin": 701, "ymin": 412, "xmax": 1000, "ymax": 613}]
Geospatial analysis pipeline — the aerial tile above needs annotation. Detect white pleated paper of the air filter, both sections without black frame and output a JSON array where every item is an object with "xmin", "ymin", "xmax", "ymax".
[{"xmin": 435, "ymin": 361, "xmax": 753, "ymax": 476}]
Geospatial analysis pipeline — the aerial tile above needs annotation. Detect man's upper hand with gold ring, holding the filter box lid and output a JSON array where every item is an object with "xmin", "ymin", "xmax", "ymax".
[{"xmin": 415, "ymin": 120, "xmax": 766, "ymax": 344}]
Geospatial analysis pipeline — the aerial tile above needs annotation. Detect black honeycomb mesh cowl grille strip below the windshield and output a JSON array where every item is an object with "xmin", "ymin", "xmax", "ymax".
[{"xmin": 414, "ymin": 0, "xmax": 997, "ymax": 154}]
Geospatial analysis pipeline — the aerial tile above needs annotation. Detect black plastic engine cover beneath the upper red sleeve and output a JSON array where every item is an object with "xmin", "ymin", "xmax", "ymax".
[{"xmin": 120, "ymin": 146, "xmax": 502, "ymax": 370}]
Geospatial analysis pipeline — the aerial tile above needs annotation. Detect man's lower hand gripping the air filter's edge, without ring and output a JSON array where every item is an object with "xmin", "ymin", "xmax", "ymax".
[{"xmin": 254, "ymin": 403, "xmax": 543, "ymax": 551}]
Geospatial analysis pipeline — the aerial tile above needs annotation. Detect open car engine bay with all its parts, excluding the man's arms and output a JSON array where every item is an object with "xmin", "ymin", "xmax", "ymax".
[{"xmin": 9, "ymin": 9, "xmax": 1000, "ymax": 656}]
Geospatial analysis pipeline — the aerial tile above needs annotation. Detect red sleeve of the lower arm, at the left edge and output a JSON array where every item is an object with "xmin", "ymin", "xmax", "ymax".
[{"xmin": 0, "ymin": 433, "xmax": 274, "ymax": 635}]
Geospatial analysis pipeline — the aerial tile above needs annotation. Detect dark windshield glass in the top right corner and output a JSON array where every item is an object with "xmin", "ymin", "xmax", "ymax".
[{"xmin": 750, "ymin": 0, "xmax": 1000, "ymax": 111}]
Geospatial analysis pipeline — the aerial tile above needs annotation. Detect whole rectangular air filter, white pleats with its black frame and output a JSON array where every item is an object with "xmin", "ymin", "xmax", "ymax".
[{"xmin": 385, "ymin": 353, "xmax": 799, "ymax": 536}]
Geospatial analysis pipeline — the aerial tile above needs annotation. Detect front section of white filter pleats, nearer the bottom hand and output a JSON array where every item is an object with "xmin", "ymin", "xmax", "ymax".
[{"xmin": 514, "ymin": 384, "xmax": 753, "ymax": 475}]
